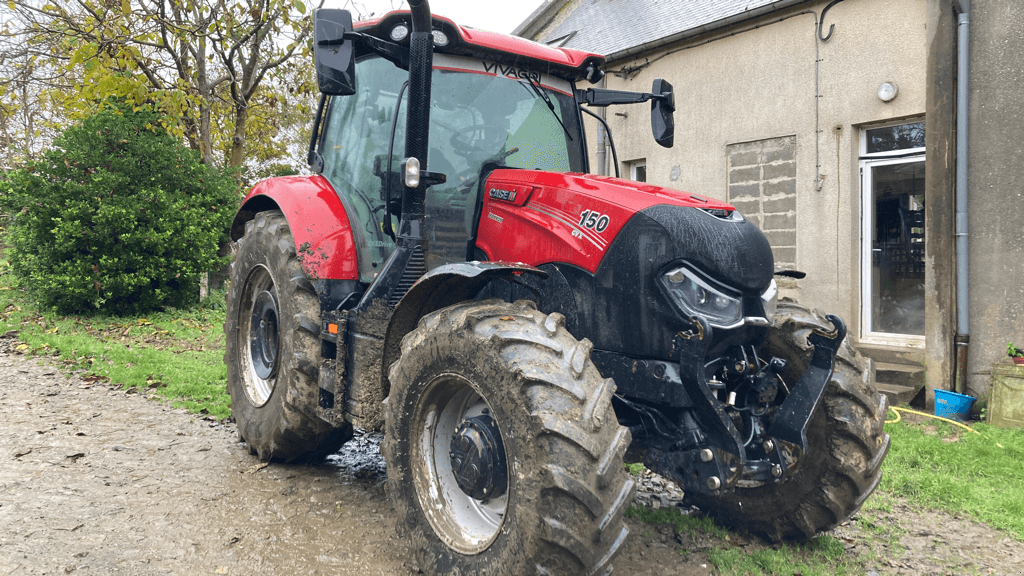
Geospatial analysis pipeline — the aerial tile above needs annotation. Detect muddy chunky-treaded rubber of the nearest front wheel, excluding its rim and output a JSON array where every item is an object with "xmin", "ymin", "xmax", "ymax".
[{"xmin": 383, "ymin": 299, "xmax": 635, "ymax": 576}]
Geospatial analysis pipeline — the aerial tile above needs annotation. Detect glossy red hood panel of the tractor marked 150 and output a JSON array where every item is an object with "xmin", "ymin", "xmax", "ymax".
[{"xmin": 476, "ymin": 170, "xmax": 734, "ymax": 274}]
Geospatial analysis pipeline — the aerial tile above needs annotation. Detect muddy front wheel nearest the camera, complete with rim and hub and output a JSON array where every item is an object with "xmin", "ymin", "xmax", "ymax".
[{"xmin": 383, "ymin": 300, "xmax": 635, "ymax": 576}]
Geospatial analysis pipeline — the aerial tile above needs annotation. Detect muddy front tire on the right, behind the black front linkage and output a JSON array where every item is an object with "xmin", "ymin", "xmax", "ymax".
[{"xmin": 692, "ymin": 302, "xmax": 889, "ymax": 541}]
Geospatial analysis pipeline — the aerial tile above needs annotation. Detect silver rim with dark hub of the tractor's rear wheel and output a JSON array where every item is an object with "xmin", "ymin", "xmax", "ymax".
[{"xmin": 238, "ymin": 265, "xmax": 281, "ymax": 408}]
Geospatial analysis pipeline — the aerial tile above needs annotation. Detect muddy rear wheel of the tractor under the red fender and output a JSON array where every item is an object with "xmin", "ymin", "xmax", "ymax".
[{"xmin": 224, "ymin": 210, "xmax": 352, "ymax": 461}]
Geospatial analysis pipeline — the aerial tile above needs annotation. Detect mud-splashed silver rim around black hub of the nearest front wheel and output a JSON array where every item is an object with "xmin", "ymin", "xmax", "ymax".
[{"xmin": 411, "ymin": 374, "xmax": 511, "ymax": 554}]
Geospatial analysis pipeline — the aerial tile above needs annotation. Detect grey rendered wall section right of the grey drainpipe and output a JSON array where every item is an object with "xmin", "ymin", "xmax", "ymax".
[{"xmin": 968, "ymin": 0, "xmax": 1024, "ymax": 398}]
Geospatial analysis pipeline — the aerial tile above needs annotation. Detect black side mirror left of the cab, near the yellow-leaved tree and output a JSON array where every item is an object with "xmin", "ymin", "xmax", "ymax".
[{"xmin": 313, "ymin": 9, "xmax": 355, "ymax": 96}]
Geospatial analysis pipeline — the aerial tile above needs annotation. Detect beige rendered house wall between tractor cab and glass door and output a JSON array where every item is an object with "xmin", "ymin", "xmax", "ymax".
[{"xmin": 577, "ymin": 0, "xmax": 927, "ymax": 344}]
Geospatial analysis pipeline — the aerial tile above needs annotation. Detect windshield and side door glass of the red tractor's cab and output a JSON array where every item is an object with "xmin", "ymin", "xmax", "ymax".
[{"xmin": 321, "ymin": 54, "xmax": 585, "ymax": 282}]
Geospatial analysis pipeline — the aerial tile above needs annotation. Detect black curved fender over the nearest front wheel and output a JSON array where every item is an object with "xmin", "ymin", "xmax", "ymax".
[{"xmin": 381, "ymin": 261, "xmax": 548, "ymax": 398}]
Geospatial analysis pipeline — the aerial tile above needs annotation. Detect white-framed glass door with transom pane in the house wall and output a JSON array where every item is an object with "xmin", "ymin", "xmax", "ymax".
[{"xmin": 860, "ymin": 120, "xmax": 925, "ymax": 347}]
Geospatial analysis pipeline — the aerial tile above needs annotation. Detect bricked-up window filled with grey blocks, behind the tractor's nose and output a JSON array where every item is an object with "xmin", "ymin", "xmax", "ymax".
[{"xmin": 725, "ymin": 136, "xmax": 797, "ymax": 269}]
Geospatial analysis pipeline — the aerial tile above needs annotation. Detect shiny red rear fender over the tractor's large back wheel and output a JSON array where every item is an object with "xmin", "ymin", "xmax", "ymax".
[{"xmin": 231, "ymin": 175, "xmax": 359, "ymax": 280}]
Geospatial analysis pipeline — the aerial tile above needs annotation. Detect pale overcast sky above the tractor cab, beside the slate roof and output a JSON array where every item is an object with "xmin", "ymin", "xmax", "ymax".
[{"xmin": 339, "ymin": 0, "xmax": 543, "ymax": 34}]
